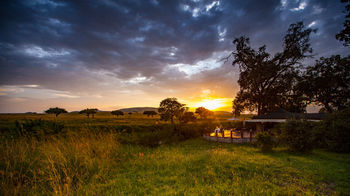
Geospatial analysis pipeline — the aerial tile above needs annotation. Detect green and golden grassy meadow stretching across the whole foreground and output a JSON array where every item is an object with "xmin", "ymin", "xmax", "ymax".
[{"xmin": 0, "ymin": 112, "xmax": 350, "ymax": 195}]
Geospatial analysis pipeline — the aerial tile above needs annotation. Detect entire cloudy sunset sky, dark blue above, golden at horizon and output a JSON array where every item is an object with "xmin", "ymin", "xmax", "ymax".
[{"xmin": 0, "ymin": 0, "xmax": 349, "ymax": 113}]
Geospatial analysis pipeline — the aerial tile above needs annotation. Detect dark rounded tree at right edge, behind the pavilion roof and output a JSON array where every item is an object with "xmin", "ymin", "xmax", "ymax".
[{"xmin": 300, "ymin": 55, "xmax": 350, "ymax": 113}]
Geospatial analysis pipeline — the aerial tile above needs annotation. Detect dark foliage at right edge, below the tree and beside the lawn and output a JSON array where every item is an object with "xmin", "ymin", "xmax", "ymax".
[{"xmin": 315, "ymin": 108, "xmax": 350, "ymax": 153}]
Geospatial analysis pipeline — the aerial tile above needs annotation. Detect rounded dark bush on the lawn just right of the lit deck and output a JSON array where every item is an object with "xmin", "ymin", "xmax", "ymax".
[{"xmin": 279, "ymin": 120, "xmax": 314, "ymax": 152}]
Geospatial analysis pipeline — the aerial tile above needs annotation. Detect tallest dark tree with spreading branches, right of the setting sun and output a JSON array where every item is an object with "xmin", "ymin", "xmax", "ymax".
[{"xmin": 230, "ymin": 22, "xmax": 316, "ymax": 115}]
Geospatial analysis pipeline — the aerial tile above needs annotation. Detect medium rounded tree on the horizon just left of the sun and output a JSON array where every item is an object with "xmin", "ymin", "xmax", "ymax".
[{"xmin": 158, "ymin": 98, "xmax": 186, "ymax": 124}]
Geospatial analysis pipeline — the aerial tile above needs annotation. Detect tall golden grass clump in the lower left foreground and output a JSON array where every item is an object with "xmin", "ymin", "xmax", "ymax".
[{"xmin": 0, "ymin": 131, "xmax": 119, "ymax": 195}]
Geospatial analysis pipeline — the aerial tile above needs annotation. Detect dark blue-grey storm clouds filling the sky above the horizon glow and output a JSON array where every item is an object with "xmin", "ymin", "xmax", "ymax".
[{"xmin": 0, "ymin": 0, "xmax": 346, "ymax": 110}]
